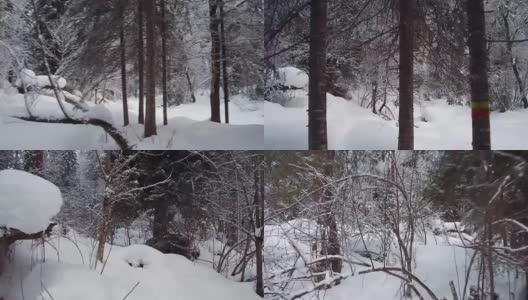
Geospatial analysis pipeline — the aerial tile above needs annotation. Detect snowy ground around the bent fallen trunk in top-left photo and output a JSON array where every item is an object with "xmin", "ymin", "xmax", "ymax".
[{"xmin": 0, "ymin": 89, "xmax": 264, "ymax": 150}]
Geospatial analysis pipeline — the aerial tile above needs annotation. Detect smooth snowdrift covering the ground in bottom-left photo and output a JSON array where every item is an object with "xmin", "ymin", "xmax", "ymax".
[{"xmin": 0, "ymin": 230, "xmax": 258, "ymax": 300}]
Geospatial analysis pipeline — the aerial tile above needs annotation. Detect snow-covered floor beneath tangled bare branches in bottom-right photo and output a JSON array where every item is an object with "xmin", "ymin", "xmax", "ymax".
[{"xmin": 265, "ymin": 219, "xmax": 527, "ymax": 300}]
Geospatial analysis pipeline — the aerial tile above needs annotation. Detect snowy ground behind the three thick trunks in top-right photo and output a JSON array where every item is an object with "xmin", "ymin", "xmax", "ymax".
[{"xmin": 264, "ymin": 67, "xmax": 528, "ymax": 150}]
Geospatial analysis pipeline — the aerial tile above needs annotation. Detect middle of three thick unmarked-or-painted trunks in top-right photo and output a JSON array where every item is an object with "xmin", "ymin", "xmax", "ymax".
[{"xmin": 398, "ymin": 0, "xmax": 414, "ymax": 150}]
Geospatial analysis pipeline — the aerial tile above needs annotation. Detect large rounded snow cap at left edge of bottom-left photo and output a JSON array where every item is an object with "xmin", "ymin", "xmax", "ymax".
[{"xmin": 0, "ymin": 170, "xmax": 62, "ymax": 233}]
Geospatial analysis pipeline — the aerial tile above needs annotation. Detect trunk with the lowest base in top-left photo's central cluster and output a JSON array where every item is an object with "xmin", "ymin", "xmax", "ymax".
[{"xmin": 144, "ymin": 0, "xmax": 156, "ymax": 137}]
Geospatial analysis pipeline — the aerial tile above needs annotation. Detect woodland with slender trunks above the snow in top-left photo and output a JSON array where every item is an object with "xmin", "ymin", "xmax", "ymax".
[{"xmin": 0, "ymin": 0, "xmax": 264, "ymax": 137}]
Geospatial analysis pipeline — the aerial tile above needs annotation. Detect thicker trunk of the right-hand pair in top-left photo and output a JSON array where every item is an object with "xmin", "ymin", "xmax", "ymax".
[{"xmin": 209, "ymin": 0, "xmax": 221, "ymax": 123}]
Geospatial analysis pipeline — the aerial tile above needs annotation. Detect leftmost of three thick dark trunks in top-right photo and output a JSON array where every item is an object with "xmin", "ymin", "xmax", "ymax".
[{"xmin": 308, "ymin": 0, "xmax": 328, "ymax": 150}]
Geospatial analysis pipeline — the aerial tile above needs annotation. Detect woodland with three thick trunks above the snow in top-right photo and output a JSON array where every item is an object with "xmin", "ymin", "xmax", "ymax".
[{"xmin": 265, "ymin": 0, "xmax": 528, "ymax": 149}]
